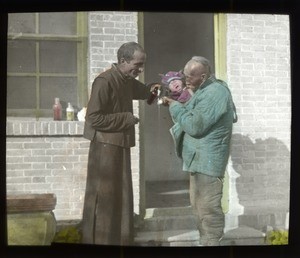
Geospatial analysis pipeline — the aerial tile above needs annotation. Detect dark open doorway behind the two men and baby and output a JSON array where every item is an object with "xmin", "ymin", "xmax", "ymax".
[{"xmin": 140, "ymin": 12, "xmax": 214, "ymax": 208}]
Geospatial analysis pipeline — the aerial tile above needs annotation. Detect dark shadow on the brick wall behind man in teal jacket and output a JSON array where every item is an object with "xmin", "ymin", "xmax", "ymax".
[{"xmin": 231, "ymin": 134, "xmax": 290, "ymax": 214}]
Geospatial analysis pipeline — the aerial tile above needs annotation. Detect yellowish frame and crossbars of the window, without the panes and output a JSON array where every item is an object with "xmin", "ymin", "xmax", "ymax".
[{"xmin": 7, "ymin": 12, "xmax": 88, "ymax": 120}]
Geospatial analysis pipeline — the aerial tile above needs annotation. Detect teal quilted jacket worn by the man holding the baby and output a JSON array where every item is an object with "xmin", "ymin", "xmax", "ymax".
[{"xmin": 169, "ymin": 76, "xmax": 235, "ymax": 177}]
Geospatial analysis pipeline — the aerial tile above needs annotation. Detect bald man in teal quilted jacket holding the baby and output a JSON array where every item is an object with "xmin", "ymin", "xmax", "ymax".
[{"xmin": 164, "ymin": 56, "xmax": 236, "ymax": 246}]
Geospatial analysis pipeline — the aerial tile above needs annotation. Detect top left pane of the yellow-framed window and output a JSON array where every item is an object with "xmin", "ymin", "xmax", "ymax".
[{"xmin": 8, "ymin": 13, "xmax": 35, "ymax": 33}]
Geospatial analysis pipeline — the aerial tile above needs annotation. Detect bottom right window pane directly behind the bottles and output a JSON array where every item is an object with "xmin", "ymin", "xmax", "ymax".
[{"xmin": 40, "ymin": 77, "xmax": 77, "ymax": 109}]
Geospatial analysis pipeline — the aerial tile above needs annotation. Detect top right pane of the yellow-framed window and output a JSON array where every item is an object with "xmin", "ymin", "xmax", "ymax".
[{"xmin": 40, "ymin": 12, "xmax": 76, "ymax": 35}]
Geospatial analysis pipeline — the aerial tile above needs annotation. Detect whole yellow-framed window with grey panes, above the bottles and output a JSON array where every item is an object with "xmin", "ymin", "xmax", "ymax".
[{"xmin": 7, "ymin": 12, "xmax": 88, "ymax": 118}]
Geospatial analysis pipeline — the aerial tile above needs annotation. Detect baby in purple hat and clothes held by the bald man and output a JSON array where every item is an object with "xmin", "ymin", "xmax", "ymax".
[{"xmin": 161, "ymin": 71, "xmax": 193, "ymax": 103}]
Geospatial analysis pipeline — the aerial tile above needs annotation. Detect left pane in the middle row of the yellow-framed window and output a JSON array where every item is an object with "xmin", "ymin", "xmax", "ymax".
[{"xmin": 7, "ymin": 40, "xmax": 36, "ymax": 73}]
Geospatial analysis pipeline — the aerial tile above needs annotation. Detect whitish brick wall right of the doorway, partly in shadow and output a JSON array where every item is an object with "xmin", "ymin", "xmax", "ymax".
[{"xmin": 227, "ymin": 14, "xmax": 291, "ymax": 221}]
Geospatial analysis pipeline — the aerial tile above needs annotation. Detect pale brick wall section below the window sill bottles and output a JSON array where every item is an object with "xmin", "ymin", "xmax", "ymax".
[{"xmin": 6, "ymin": 119, "xmax": 89, "ymax": 220}]
